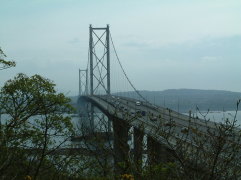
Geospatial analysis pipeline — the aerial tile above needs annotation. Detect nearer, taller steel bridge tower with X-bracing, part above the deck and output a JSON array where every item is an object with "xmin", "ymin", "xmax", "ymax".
[{"xmin": 89, "ymin": 25, "xmax": 110, "ymax": 95}]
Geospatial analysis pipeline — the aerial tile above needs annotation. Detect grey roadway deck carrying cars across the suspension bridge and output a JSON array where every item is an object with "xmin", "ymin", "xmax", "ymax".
[{"xmin": 82, "ymin": 95, "xmax": 216, "ymax": 148}]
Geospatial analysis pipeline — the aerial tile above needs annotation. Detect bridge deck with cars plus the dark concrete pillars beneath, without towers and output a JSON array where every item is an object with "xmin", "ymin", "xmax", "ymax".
[{"xmin": 79, "ymin": 95, "xmax": 216, "ymax": 173}]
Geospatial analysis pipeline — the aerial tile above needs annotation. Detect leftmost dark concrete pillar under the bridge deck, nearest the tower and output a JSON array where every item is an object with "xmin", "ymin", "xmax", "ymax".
[{"xmin": 112, "ymin": 119, "xmax": 130, "ymax": 175}]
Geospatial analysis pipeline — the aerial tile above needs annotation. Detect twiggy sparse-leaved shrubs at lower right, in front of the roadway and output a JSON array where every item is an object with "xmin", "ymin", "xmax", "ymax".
[{"xmin": 146, "ymin": 104, "xmax": 241, "ymax": 180}]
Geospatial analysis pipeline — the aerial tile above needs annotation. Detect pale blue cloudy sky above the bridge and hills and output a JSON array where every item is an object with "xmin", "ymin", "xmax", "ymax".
[{"xmin": 0, "ymin": 0, "xmax": 241, "ymax": 95}]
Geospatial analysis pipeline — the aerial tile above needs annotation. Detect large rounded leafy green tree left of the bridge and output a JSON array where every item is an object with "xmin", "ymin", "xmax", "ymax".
[{"xmin": 0, "ymin": 74, "xmax": 73, "ymax": 179}]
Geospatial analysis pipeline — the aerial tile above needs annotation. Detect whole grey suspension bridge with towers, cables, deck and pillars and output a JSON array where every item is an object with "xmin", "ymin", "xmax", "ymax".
[{"xmin": 78, "ymin": 25, "xmax": 218, "ymax": 174}]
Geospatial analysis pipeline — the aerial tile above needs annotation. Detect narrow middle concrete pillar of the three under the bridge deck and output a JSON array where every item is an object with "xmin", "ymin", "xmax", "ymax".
[{"xmin": 134, "ymin": 128, "xmax": 144, "ymax": 179}]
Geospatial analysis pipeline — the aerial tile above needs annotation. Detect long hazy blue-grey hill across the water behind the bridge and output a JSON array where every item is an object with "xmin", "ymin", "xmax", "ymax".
[{"xmin": 71, "ymin": 89, "xmax": 241, "ymax": 112}]
